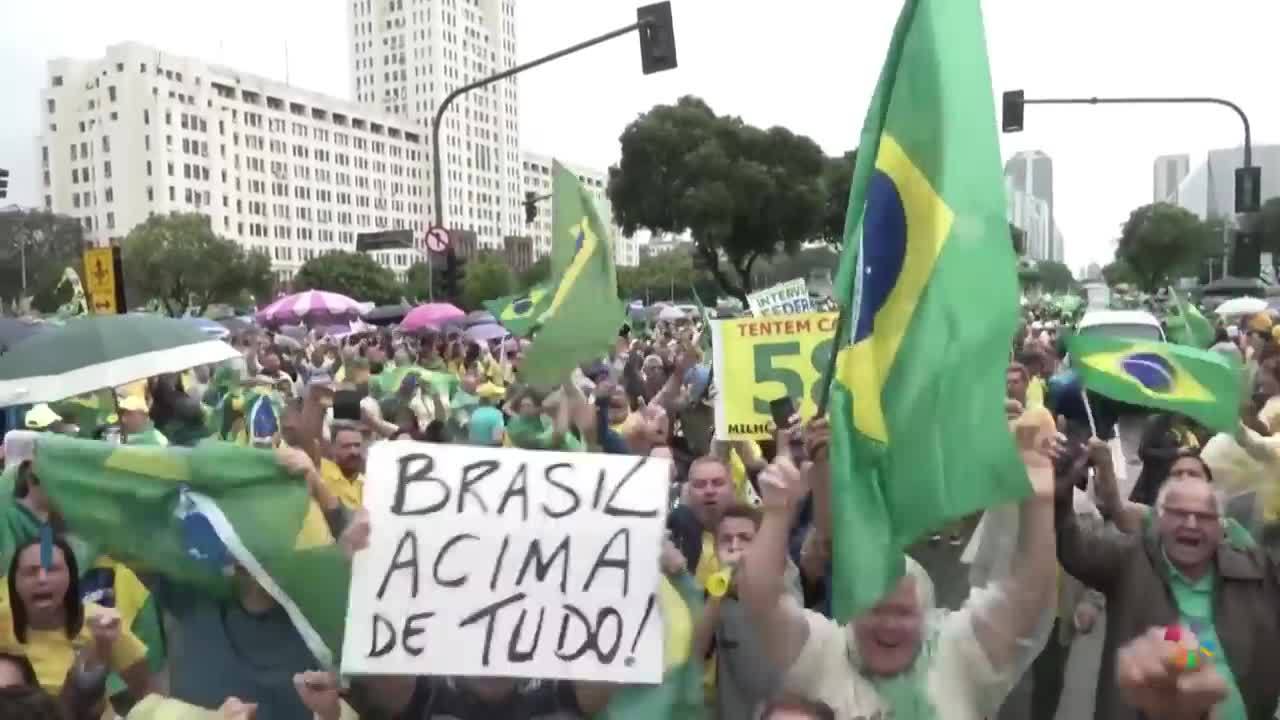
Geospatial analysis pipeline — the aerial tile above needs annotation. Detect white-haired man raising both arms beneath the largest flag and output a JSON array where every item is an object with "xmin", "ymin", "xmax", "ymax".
[{"xmin": 739, "ymin": 427, "xmax": 1056, "ymax": 720}]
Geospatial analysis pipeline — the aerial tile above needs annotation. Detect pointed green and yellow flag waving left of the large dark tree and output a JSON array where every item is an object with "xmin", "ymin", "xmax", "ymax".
[{"xmin": 520, "ymin": 163, "xmax": 626, "ymax": 387}]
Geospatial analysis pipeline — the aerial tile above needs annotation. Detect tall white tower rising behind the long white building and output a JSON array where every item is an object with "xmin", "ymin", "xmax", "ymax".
[{"xmin": 347, "ymin": 0, "xmax": 524, "ymax": 250}]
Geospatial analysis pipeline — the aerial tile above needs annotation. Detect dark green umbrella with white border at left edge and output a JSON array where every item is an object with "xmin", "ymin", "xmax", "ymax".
[{"xmin": 0, "ymin": 315, "xmax": 239, "ymax": 407}]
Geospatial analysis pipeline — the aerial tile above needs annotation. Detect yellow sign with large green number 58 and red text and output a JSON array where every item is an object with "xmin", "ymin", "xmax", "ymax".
[{"xmin": 712, "ymin": 313, "xmax": 838, "ymax": 439}]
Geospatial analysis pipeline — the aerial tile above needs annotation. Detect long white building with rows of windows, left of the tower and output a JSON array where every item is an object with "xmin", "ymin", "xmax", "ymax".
[{"xmin": 38, "ymin": 44, "xmax": 431, "ymax": 279}]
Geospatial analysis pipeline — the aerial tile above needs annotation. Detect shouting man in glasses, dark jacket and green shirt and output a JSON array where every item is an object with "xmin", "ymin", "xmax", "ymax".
[{"xmin": 1056, "ymin": 445, "xmax": 1280, "ymax": 720}]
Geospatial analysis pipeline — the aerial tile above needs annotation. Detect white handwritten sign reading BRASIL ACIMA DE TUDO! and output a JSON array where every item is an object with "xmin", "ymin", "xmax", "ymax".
[{"xmin": 342, "ymin": 441, "xmax": 669, "ymax": 684}]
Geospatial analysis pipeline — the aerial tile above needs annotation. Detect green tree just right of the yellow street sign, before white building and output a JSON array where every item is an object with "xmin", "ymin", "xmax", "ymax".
[{"xmin": 122, "ymin": 213, "xmax": 274, "ymax": 315}]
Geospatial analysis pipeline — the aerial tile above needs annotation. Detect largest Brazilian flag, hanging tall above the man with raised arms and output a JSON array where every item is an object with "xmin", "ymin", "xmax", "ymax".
[{"xmin": 829, "ymin": 0, "xmax": 1030, "ymax": 620}]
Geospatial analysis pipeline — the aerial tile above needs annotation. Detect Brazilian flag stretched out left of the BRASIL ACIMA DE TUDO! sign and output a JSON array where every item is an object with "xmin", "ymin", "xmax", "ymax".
[{"xmin": 24, "ymin": 433, "xmax": 351, "ymax": 669}]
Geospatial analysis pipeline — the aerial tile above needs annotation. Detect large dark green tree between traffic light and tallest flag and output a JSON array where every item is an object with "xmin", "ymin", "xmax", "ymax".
[{"xmin": 608, "ymin": 97, "xmax": 827, "ymax": 302}]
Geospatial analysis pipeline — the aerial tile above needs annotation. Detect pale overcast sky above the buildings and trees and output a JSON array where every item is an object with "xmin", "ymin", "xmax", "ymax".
[{"xmin": 0, "ymin": 0, "xmax": 1280, "ymax": 269}]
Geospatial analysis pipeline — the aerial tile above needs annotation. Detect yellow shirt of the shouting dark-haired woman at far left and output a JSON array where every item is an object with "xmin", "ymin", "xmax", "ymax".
[{"xmin": 0, "ymin": 597, "xmax": 147, "ymax": 696}]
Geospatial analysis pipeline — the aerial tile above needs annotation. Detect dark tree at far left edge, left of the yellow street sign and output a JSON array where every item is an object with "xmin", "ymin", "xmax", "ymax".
[{"xmin": 0, "ymin": 210, "xmax": 84, "ymax": 313}]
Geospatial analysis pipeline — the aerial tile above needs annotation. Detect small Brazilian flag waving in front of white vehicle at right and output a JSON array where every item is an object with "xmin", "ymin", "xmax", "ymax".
[{"xmin": 1066, "ymin": 334, "xmax": 1240, "ymax": 433}]
